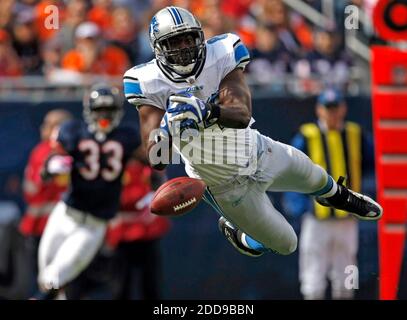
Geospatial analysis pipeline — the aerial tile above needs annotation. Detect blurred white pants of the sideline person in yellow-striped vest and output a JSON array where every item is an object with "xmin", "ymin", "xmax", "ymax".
[{"xmin": 299, "ymin": 214, "xmax": 358, "ymax": 300}]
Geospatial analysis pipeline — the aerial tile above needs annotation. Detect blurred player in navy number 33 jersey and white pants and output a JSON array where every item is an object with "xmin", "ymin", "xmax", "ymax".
[{"xmin": 38, "ymin": 85, "xmax": 140, "ymax": 296}]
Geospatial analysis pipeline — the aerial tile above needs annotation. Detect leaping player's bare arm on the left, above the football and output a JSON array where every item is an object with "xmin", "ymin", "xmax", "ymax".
[{"xmin": 139, "ymin": 105, "xmax": 167, "ymax": 170}]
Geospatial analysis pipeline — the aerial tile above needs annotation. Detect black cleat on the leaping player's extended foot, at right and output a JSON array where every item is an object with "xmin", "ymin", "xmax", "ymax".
[{"xmin": 315, "ymin": 177, "xmax": 383, "ymax": 220}]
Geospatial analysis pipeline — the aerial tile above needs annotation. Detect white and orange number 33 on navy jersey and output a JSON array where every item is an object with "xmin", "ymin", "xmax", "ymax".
[{"xmin": 78, "ymin": 139, "xmax": 123, "ymax": 181}]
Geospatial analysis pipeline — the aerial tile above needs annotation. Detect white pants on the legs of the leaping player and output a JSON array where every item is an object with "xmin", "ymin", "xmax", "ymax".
[{"xmin": 209, "ymin": 134, "xmax": 328, "ymax": 255}]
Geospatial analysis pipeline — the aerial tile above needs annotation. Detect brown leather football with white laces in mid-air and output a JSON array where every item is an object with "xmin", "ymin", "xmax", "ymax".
[{"xmin": 150, "ymin": 177, "xmax": 206, "ymax": 216}]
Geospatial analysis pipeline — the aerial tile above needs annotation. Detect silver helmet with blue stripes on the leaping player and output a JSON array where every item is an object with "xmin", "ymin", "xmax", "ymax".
[{"xmin": 149, "ymin": 7, "xmax": 206, "ymax": 78}]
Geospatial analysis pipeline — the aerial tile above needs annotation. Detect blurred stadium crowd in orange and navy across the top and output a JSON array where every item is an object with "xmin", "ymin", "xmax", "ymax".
[{"xmin": 0, "ymin": 0, "xmax": 374, "ymax": 89}]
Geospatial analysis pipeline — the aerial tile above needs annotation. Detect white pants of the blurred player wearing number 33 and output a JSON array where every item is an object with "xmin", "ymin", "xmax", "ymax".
[{"xmin": 38, "ymin": 201, "xmax": 106, "ymax": 289}]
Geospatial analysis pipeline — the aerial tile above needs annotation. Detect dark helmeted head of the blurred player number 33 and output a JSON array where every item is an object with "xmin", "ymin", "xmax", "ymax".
[{"xmin": 83, "ymin": 84, "xmax": 123, "ymax": 140}]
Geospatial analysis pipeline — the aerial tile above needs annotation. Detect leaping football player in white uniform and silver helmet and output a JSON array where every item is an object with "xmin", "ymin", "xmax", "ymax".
[{"xmin": 124, "ymin": 7, "xmax": 382, "ymax": 257}]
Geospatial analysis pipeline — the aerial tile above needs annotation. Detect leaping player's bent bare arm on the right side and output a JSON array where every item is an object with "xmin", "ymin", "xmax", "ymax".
[{"xmin": 217, "ymin": 69, "xmax": 252, "ymax": 129}]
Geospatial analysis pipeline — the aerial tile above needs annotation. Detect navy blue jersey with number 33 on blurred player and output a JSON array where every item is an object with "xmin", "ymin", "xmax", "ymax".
[{"xmin": 58, "ymin": 120, "xmax": 140, "ymax": 220}]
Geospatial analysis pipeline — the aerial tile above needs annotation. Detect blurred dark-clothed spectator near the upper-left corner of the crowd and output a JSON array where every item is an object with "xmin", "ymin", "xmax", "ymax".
[{"xmin": 13, "ymin": 10, "xmax": 42, "ymax": 75}]
